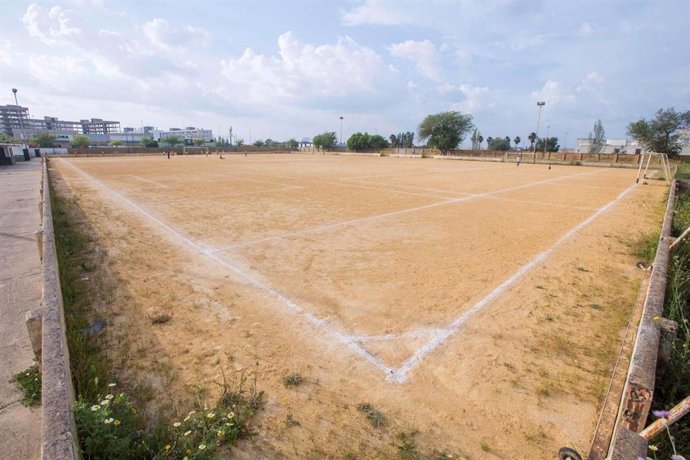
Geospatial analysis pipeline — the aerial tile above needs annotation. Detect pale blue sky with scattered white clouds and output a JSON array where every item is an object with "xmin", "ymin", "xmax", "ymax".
[{"xmin": 0, "ymin": 0, "xmax": 690, "ymax": 147}]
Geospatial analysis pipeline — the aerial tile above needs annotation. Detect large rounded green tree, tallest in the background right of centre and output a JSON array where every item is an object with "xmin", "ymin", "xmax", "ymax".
[{"xmin": 419, "ymin": 112, "xmax": 474, "ymax": 155}]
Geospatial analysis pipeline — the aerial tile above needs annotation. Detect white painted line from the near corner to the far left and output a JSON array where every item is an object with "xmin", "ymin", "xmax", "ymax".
[{"xmin": 63, "ymin": 161, "xmax": 394, "ymax": 375}]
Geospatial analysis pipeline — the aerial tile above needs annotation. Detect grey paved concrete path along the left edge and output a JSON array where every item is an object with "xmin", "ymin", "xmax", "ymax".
[{"xmin": 0, "ymin": 158, "xmax": 42, "ymax": 459}]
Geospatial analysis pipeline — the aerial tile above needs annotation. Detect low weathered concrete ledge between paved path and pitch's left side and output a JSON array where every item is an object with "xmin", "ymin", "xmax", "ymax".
[{"xmin": 38, "ymin": 160, "xmax": 79, "ymax": 460}]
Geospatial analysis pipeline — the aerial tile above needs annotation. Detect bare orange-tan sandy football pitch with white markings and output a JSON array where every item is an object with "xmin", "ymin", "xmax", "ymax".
[{"xmin": 51, "ymin": 155, "xmax": 667, "ymax": 459}]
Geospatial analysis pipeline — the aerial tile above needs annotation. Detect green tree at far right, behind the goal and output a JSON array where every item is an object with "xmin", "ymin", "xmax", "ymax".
[{"xmin": 628, "ymin": 107, "xmax": 690, "ymax": 155}]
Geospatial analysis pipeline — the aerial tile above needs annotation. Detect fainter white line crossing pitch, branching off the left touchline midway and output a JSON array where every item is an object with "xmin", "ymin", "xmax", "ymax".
[{"xmin": 216, "ymin": 167, "xmax": 602, "ymax": 251}]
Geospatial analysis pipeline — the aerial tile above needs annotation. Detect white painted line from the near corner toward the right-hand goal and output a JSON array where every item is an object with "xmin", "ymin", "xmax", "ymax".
[{"xmin": 388, "ymin": 184, "xmax": 636, "ymax": 383}]
